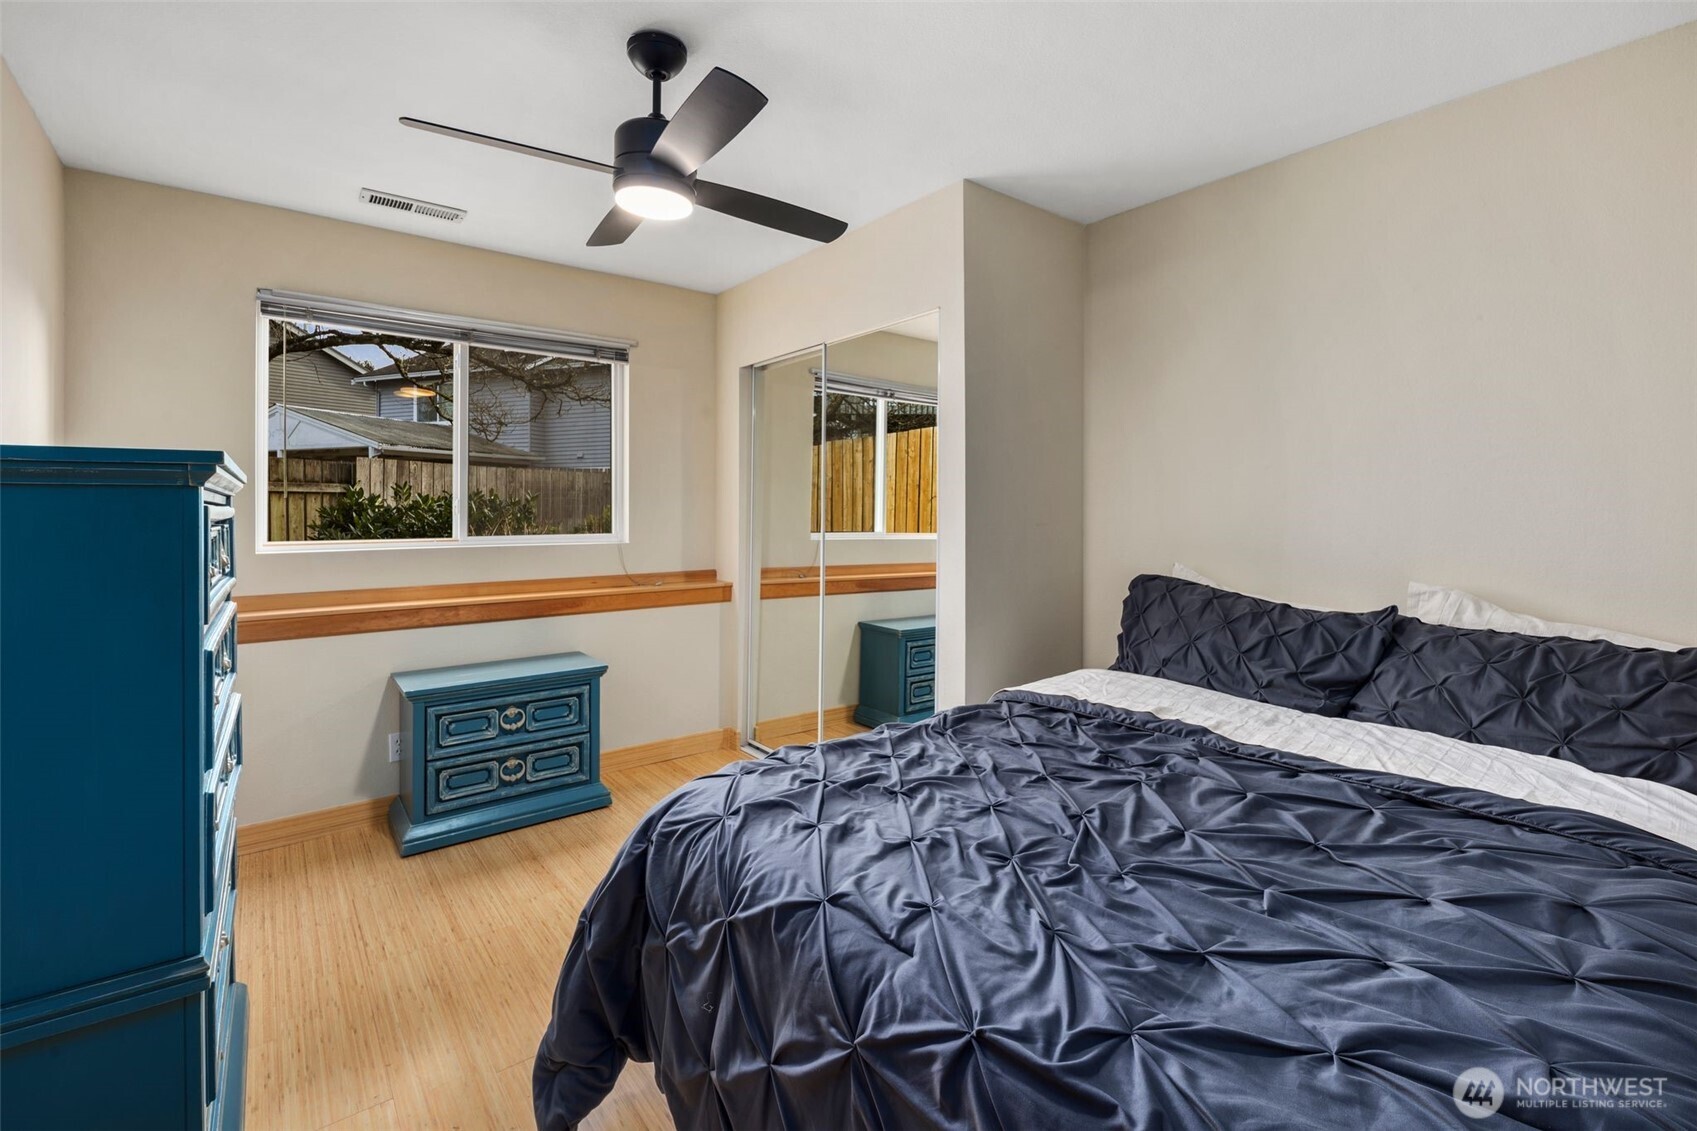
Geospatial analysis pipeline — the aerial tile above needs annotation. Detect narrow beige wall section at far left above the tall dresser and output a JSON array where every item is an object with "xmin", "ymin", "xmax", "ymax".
[{"xmin": 0, "ymin": 59, "xmax": 64, "ymax": 443}]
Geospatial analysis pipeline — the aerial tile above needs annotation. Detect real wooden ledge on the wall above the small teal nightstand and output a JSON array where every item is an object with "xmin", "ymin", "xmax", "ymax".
[{"xmin": 238, "ymin": 569, "xmax": 731, "ymax": 645}]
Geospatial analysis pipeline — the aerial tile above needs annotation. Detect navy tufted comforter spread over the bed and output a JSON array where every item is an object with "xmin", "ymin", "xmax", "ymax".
[{"xmin": 535, "ymin": 691, "xmax": 1697, "ymax": 1131}]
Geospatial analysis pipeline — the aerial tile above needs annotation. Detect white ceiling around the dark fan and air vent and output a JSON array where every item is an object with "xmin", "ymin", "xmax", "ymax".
[{"xmin": 0, "ymin": 0, "xmax": 1697, "ymax": 292}]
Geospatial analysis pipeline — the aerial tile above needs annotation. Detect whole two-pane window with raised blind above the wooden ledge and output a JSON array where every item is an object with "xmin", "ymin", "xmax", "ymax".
[{"xmin": 258, "ymin": 290, "xmax": 628, "ymax": 549}]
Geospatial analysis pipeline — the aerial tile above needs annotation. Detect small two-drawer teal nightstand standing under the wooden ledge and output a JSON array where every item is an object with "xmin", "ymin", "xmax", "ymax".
[{"xmin": 389, "ymin": 652, "xmax": 613, "ymax": 856}]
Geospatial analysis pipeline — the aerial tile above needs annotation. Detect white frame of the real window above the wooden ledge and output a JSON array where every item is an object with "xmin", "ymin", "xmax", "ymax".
[{"xmin": 253, "ymin": 294, "xmax": 636, "ymax": 554}]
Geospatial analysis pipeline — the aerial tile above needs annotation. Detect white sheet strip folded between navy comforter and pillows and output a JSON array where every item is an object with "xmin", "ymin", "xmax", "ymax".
[{"xmin": 1020, "ymin": 667, "xmax": 1697, "ymax": 849}]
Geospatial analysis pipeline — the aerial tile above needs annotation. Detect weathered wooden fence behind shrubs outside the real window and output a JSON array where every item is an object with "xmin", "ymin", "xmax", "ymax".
[{"xmin": 268, "ymin": 455, "xmax": 613, "ymax": 542}]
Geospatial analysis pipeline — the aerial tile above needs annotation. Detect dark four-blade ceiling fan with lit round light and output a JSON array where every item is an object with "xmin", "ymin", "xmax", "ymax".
[{"xmin": 400, "ymin": 31, "xmax": 849, "ymax": 248}]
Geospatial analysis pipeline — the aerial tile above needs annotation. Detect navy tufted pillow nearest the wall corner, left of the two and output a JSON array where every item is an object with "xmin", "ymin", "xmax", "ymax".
[{"xmin": 1113, "ymin": 574, "xmax": 1397, "ymax": 715}]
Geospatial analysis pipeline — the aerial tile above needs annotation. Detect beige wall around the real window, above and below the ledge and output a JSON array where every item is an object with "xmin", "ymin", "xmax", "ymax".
[{"xmin": 64, "ymin": 172, "xmax": 723, "ymax": 820}]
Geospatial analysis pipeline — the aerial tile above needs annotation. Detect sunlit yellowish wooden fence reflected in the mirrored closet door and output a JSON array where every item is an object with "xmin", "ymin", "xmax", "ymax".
[{"xmin": 813, "ymin": 428, "xmax": 937, "ymax": 533}]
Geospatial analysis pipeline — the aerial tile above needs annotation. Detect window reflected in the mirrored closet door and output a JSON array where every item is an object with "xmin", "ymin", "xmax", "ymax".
[{"xmin": 813, "ymin": 374, "xmax": 937, "ymax": 535}]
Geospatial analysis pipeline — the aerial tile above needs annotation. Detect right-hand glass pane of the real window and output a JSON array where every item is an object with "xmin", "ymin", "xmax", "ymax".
[{"xmin": 465, "ymin": 348, "xmax": 613, "ymax": 537}]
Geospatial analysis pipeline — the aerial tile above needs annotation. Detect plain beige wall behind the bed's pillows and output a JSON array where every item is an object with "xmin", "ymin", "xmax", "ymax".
[{"xmin": 1086, "ymin": 25, "xmax": 1697, "ymax": 662}]
